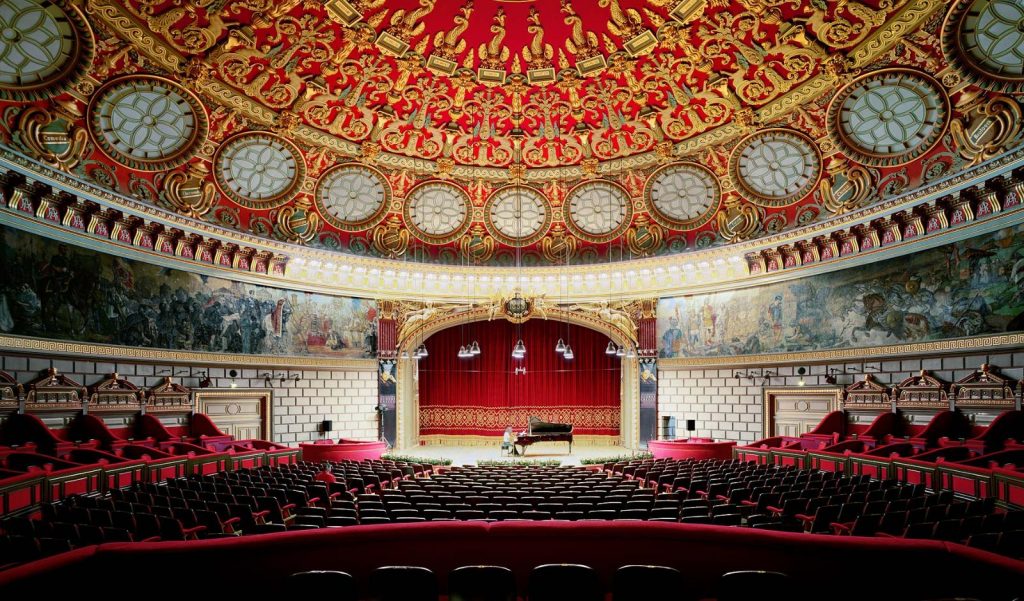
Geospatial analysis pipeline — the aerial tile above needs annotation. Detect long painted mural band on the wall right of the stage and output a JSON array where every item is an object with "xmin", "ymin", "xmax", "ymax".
[{"xmin": 657, "ymin": 225, "xmax": 1024, "ymax": 357}]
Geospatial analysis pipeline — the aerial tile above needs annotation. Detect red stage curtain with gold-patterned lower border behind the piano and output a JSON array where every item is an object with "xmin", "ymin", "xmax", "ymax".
[{"xmin": 419, "ymin": 319, "xmax": 622, "ymax": 436}]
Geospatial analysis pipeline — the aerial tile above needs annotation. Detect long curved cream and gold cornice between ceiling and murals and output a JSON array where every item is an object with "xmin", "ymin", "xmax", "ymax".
[{"xmin": 6, "ymin": 146, "xmax": 1024, "ymax": 302}]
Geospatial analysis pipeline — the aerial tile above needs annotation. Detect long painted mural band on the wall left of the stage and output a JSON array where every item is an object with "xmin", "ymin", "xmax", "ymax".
[{"xmin": 0, "ymin": 226, "xmax": 377, "ymax": 357}]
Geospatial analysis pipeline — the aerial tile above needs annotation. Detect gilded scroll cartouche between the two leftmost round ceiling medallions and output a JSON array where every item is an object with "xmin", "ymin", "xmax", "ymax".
[{"xmin": 14, "ymin": 104, "xmax": 89, "ymax": 171}]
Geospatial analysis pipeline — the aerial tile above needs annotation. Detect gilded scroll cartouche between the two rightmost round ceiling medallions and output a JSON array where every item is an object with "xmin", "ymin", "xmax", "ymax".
[{"xmin": 949, "ymin": 96, "xmax": 1022, "ymax": 167}]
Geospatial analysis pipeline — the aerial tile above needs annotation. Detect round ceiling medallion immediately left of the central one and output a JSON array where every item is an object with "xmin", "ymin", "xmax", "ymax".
[{"xmin": 402, "ymin": 181, "xmax": 472, "ymax": 244}]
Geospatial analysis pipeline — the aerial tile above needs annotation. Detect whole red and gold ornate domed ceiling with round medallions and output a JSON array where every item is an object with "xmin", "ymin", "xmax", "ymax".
[{"xmin": 0, "ymin": 0, "xmax": 1024, "ymax": 265}]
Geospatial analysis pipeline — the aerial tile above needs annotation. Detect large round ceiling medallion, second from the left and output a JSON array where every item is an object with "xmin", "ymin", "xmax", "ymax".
[{"xmin": 88, "ymin": 76, "xmax": 209, "ymax": 171}]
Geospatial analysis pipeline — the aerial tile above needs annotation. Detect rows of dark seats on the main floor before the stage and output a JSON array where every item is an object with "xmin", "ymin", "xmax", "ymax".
[{"xmin": 4, "ymin": 458, "xmax": 1024, "ymax": 573}]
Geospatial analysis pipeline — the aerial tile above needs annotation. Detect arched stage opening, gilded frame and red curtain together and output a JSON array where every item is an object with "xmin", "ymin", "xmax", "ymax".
[{"xmin": 396, "ymin": 310, "xmax": 639, "ymax": 448}]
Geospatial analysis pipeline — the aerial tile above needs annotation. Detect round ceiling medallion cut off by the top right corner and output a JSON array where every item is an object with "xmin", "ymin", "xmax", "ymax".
[{"xmin": 942, "ymin": 0, "xmax": 1024, "ymax": 92}]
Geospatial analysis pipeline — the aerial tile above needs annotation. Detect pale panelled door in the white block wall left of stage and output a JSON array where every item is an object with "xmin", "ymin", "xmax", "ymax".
[{"xmin": 196, "ymin": 388, "xmax": 273, "ymax": 440}]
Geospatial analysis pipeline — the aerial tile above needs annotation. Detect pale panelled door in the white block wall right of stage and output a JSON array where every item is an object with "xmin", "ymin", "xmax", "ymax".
[{"xmin": 764, "ymin": 386, "xmax": 843, "ymax": 438}]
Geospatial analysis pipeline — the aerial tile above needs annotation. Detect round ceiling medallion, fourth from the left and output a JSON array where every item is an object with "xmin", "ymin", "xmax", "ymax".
[{"xmin": 313, "ymin": 163, "xmax": 391, "ymax": 231}]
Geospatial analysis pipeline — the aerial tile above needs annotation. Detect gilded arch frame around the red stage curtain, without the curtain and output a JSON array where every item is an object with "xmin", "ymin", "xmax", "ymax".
[{"xmin": 395, "ymin": 307, "xmax": 640, "ymax": 449}]
